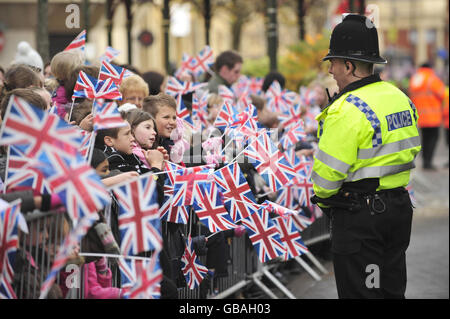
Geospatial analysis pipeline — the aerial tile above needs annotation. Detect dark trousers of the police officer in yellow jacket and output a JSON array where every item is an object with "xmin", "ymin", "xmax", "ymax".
[{"xmin": 331, "ymin": 189, "xmax": 412, "ymax": 298}]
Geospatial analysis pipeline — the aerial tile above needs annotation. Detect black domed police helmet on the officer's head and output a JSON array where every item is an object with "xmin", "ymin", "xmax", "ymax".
[{"xmin": 322, "ymin": 14, "xmax": 387, "ymax": 64}]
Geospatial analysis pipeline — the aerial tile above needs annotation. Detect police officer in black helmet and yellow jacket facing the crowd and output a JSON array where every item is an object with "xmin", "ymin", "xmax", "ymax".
[{"xmin": 312, "ymin": 14, "xmax": 421, "ymax": 298}]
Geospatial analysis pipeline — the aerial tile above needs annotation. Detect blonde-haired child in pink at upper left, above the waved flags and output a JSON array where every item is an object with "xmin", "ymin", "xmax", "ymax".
[{"xmin": 50, "ymin": 51, "xmax": 83, "ymax": 118}]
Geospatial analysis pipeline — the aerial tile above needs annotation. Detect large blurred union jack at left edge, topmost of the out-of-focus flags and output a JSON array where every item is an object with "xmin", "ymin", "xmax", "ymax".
[{"xmin": 0, "ymin": 95, "xmax": 82, "ymax": 158}]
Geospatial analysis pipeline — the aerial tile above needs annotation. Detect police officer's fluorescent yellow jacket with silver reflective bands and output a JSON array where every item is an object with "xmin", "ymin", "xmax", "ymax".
[{"xmin": 312, "ymin": 75, "xmax": 421, "ymax": 198}]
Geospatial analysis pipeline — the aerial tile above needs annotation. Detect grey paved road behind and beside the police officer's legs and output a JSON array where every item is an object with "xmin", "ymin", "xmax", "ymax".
[{"xmin": 287, "ymin": 128, "xmax": 449, "ymax": 299}]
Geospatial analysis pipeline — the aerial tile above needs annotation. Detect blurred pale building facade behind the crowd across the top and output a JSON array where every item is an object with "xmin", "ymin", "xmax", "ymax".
[{"xmin": 0, "ymin": 0, "xmax": 449, "ymax": 88}]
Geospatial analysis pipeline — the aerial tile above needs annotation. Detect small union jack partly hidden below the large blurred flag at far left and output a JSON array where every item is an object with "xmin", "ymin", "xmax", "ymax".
[{"xmin": 5, "ymin": 145, "xmax": 50, "ymax": 194}]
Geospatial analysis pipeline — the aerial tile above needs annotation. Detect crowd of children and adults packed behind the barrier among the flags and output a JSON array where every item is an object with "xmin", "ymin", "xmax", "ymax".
[{"xmin": 0, "ymin": 27, "xmax": 448, "ymax": 298}]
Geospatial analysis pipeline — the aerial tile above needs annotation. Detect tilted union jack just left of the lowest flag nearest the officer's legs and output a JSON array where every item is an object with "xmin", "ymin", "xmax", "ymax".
[{"xmin": 241, "ymin": 210, "xmax": 286, "ymax": 263}]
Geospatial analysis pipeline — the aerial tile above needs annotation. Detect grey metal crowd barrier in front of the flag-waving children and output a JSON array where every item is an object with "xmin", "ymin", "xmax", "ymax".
[{"xmin": 14, "ymin": 206, "xmax": 329, "ymax": 299}]
